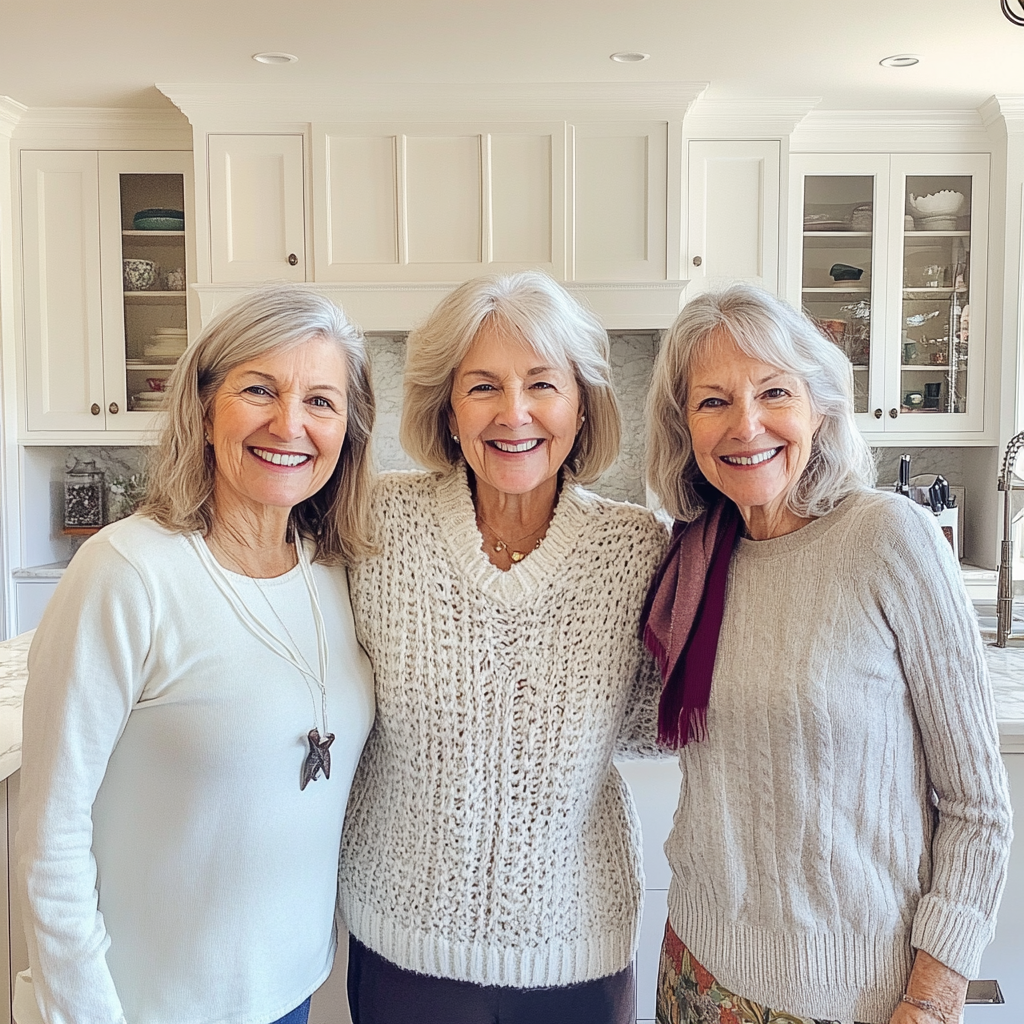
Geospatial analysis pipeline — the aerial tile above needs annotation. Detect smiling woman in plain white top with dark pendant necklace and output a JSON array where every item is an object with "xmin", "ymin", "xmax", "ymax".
[{"xmin": 17, "ymin": 289, "xmax": 374, "ymax": 1024}]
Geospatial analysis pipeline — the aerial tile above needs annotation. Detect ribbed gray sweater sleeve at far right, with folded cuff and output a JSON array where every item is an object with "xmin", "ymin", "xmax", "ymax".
[{"xmin": 865, "ymin": 498, "xmax": 1012, "ymax": 978}]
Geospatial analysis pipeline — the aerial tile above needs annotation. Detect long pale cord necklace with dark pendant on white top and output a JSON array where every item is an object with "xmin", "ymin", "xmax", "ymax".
[{"xmin": 188, "ymin": 534, "xmax": 334, "ymax": 790}]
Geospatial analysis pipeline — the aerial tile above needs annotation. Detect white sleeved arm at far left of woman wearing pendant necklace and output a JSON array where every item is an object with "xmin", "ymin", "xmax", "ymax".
[{"xmin": 17, "ymin": 535, "xmax": 153, "ymax": 1024}]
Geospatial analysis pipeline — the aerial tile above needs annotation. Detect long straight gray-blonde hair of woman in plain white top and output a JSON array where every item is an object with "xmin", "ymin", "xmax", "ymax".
[{"xmin": 139, "ymin": 286, "xmax": 375, "ymax": 564}]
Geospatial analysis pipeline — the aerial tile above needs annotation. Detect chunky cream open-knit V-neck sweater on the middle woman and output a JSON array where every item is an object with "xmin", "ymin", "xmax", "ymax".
[{"xmin": 340, "ymin": 470, "xmax": 668, "ymax": 988}]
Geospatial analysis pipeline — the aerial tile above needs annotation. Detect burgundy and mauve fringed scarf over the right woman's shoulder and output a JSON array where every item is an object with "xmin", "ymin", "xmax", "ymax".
[{"xmin": 640, "ymin": 488, "xmax": 740, "ymax": 750}]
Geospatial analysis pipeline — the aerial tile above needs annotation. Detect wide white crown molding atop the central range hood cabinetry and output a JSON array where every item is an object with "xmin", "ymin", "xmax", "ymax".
[{"xmin": 157, "ymin": 82, "xmax": 707, "ymax": 126}]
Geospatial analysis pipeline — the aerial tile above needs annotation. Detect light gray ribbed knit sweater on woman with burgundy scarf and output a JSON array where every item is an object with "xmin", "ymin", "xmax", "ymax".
[{"xmin": 666, "ymin": 492, "xmax": 1011, "ymax": 1024}]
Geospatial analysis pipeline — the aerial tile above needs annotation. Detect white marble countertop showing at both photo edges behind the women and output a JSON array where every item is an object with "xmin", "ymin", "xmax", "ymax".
[{"xmin": 0, "ymin": 613, "xmax": 1024, "ymax": 780}]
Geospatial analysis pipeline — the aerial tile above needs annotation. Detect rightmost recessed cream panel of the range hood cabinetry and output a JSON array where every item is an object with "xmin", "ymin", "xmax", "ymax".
[{"xmin": 569, "ymin": 121, "xmax": 669, "ymax": 282}]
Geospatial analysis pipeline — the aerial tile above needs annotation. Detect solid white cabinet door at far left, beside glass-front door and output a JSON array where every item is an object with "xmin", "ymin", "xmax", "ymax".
[{"xmin": 22, "ymin": 152, "xmax": 103, "ymax": 430}]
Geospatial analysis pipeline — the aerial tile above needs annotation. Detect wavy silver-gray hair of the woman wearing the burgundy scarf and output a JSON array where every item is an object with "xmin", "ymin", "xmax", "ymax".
[{"xmin": 647, "ymin": 285, "xmax": 876, "ymax": 521}]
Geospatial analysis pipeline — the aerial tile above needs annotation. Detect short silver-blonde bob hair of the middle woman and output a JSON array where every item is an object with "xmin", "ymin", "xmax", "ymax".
[{"xmin": 399, "ymin": 270, "xmax": 622, "ymax": 483}]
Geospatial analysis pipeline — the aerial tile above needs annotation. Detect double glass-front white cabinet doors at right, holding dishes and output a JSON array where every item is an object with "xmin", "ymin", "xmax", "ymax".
[{"xmin": 788, "ymin": 155, "xmax": 988, "ymax": 440}]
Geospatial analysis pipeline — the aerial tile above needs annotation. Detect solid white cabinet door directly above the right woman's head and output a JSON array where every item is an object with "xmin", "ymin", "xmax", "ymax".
[{"xmin": 684, "ymin": 139, "xmax": 780, "ymax": 297}]
